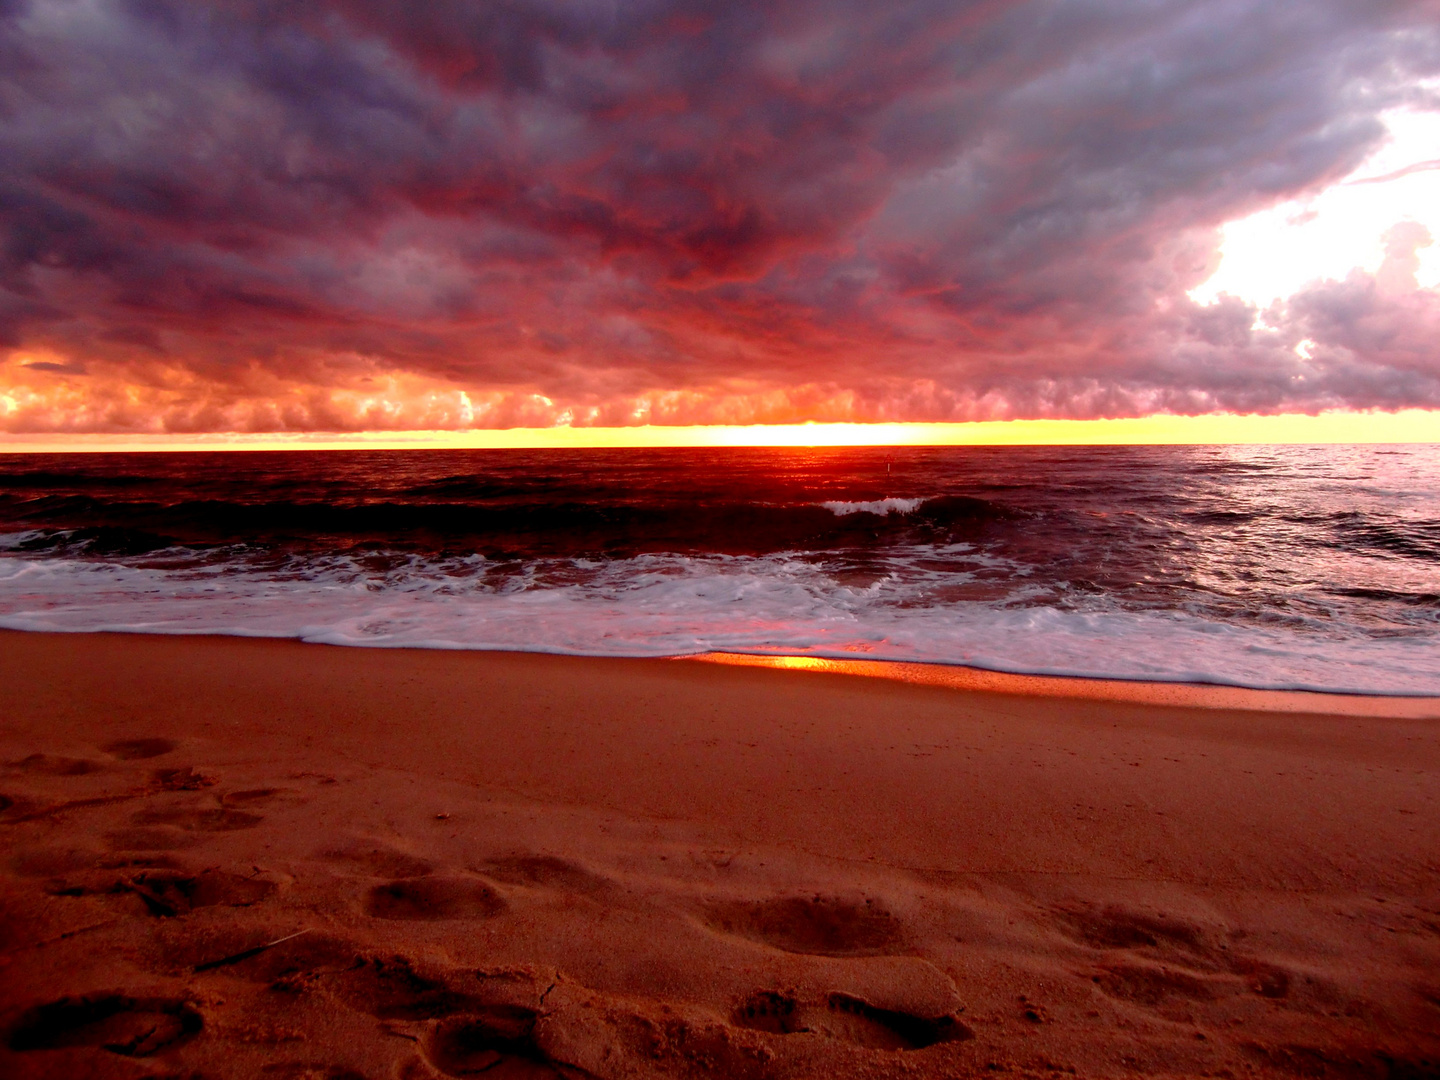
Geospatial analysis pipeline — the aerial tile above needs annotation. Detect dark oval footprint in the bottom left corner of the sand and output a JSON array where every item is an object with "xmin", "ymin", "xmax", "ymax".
[{"xmin": 9, "ymin": 994, "xmax": 204, "ymax": 1057}]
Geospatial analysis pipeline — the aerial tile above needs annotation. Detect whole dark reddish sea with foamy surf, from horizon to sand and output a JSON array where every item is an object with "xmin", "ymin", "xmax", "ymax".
[{"xmin": 0, "ymin": 446, "xmax": 1440, "ymax": 694}]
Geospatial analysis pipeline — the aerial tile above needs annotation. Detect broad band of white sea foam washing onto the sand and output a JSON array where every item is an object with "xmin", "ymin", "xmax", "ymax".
[{"xmin": 0, "ymin": 549, "xmax": 1440, "ymax": 694}]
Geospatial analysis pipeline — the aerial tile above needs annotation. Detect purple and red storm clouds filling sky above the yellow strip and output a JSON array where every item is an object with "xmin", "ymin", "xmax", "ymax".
[{"xmin": 0, "ymin": 0, "xmax": 1440, "ymax": 439}]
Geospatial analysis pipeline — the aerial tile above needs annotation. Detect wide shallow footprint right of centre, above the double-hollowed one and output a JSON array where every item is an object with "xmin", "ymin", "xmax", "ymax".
[{"xmin": 704, "ymin": 896, "xmax": 904, "ymax": 956}]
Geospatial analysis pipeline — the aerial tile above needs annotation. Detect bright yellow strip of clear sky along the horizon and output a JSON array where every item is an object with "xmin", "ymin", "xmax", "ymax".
[{"xmin": 0, "ymin": 409, "xmax": 1440, "ymax": 452}]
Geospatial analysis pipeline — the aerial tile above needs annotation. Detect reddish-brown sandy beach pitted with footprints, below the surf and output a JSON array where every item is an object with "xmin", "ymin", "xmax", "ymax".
[{"xmin": 0, "ymin": 634, "xmax": 1440, "ymax": 1080}]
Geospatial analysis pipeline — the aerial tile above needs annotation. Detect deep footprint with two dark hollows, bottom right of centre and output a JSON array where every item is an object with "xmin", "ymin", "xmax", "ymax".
[{"xmin": 732, "ymin": 991, "xmax": 975, "ymax": 1050}]
